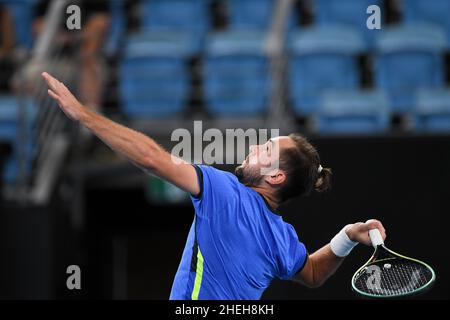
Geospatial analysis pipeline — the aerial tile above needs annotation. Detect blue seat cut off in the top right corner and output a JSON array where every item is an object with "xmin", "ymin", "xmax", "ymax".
[{"xmin": 403, "ymin": 0, "xmax": 450, "ymax": 43}]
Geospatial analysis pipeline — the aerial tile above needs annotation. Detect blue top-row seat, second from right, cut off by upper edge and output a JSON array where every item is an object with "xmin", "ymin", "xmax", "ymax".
[{"xmin": 314, "ymin": 0, "xmax": 383, "ymax": 45}]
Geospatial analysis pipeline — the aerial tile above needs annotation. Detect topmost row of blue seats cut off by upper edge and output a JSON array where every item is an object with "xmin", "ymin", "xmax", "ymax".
[{"xmin": 131, "ymin": 0, "xmax": 450, "ymax": 54}]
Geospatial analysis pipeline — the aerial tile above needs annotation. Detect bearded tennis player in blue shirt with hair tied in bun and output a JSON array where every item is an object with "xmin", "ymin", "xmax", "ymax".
[{"xmin": 42, "ymin": 73, "xmax": 386, "ymax": 300}]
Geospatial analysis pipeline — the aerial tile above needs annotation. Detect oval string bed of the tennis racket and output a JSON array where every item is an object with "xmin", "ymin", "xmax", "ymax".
[{"xmin": 355, "ymin": 259, "xmax": 432, "ymax": 296}]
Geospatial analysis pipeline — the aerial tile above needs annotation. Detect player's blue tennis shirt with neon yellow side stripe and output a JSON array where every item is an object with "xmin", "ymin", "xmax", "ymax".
[{"xmin": 170, "ymin": 165, "xmax": 308, "ymax": 300}]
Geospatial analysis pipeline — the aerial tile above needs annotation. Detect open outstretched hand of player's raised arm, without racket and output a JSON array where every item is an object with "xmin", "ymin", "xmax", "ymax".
[{"xmin": 42, "ymin": 72, "xmax": 86, "ymax": 121}]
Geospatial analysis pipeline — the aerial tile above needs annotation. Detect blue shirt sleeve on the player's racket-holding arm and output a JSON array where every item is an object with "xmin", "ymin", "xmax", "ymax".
[{"xmin": 277, "ymin": 224, "xmax": 308, "ymax": 280}]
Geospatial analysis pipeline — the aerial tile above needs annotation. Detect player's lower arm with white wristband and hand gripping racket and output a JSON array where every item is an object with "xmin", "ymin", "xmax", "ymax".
[{"xmin": 292, "ymin": 219, "xmax": 386, "ymax": 288}]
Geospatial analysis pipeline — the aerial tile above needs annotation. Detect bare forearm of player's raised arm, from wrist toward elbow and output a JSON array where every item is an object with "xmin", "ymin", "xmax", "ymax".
[{"xmin": 79, "ymin": 108, "xmax": 164, "ymax": 169}]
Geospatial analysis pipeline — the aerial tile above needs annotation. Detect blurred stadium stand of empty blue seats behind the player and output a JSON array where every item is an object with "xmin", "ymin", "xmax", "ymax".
[{"xmin": 0, "ymin": 0, "xmax": 450, "ymax": 190}]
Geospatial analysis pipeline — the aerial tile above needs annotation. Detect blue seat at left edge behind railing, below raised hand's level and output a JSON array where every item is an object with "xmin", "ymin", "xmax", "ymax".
[{"xmin": 0, "ymin": 96, "xmax": 37, "ymax": 183}]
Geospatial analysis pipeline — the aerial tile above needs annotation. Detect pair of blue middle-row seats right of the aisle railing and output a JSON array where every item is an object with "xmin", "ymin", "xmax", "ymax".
[{"xmin": 287, "ymin": 25, "xmax": 447, "ymax": 116}]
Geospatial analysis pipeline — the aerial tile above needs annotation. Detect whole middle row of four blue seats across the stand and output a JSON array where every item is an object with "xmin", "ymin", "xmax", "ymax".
[{"xmin": 120, "ymin": 25, "xmax": 446, "ymax": 116}]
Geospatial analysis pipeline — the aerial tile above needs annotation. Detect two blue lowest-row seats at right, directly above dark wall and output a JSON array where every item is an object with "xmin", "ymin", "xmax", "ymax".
[{"xmin": 313, "ymin": 88, "xmax": 450, "ymax": 134}]
